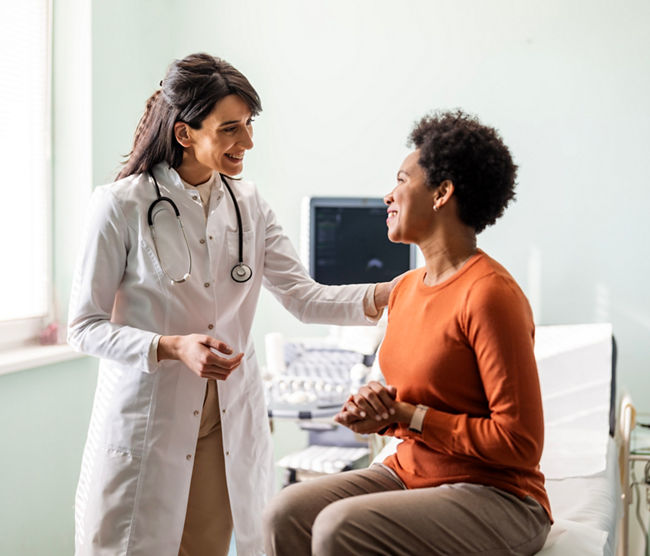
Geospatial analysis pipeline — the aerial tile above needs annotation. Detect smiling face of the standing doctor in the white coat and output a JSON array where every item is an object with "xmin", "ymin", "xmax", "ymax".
[{"xmin": 174, "ymin": 94, "xmax": 253, "ymax": 184}]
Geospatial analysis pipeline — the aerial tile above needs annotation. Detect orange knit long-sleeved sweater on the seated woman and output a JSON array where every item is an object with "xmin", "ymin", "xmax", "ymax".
[{"xmin": 379, "ymin": 251, "xmax": 551, "ymax": 517}]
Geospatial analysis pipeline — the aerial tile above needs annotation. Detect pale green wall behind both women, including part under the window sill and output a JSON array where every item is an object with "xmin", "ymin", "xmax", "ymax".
[{"xmin": 0, "ymin": 0, "xmax": 650, "ymax": 556}]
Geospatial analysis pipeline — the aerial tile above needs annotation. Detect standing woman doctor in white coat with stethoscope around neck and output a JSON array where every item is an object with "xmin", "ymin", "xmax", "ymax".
[{"xmin": 68, "ymin": 54, "xmax": 391, "ymax": 556}]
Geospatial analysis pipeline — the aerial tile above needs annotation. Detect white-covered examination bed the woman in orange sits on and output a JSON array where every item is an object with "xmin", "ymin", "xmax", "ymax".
[{"xmin": 374, "ymin": 324, "xmax": 622, "ymax": 556}]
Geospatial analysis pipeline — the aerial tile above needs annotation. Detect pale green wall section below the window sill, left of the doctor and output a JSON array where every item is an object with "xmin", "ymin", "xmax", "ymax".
[{"xmin": 0, "ymin": 358, "xmax": 96, "ymax": 556}]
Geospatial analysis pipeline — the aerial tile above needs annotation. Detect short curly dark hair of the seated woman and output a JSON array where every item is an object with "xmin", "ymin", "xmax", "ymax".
[{"xmin": 409, "ymin": 110, "xmax": 517, "ymax": 233}]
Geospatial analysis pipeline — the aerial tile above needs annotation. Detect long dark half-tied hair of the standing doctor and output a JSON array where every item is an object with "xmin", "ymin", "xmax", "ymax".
[{"xmin": 117, "ymin": 53, "xmax": 262, "ymax": 179}]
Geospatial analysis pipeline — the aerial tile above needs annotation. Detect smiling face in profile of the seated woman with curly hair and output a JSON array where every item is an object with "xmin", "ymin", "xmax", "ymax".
[{"xmin": 384, "ymin": 150, "xmax": 434, "ymax": 244}]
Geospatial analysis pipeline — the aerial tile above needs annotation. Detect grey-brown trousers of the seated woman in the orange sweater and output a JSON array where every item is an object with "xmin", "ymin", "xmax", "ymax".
[{"xmin": 264, "ymin": 465, "xmax": 551, "ymax": 556}]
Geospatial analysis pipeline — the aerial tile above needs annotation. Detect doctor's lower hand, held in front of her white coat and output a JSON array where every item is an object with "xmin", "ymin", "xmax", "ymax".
[{"xmin": 158, "ymin": 334, "xmax": 244, "ymax": 380}]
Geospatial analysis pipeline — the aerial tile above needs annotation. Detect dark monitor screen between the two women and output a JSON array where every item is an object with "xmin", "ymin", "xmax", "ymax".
[{"xmin": 308, "ymin": 197, "xmax": 416, "ymax": 285}]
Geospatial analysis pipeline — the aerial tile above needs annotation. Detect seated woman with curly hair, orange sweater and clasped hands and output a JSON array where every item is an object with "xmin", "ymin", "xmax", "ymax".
[{"xmin": 264, "ymin": 111, "xmax": 551, "ymax": 556}]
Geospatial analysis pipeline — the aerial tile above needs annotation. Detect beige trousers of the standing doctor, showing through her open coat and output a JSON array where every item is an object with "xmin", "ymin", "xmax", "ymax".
[{"xmin": 178, "ymin": 380, "xmax": 232, "ymax": 556}]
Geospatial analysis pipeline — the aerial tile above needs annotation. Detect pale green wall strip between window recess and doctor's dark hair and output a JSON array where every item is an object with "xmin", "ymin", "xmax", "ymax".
[{"xmin": 92, "ymin": 0, "xmax": 178, "ymax": 185}]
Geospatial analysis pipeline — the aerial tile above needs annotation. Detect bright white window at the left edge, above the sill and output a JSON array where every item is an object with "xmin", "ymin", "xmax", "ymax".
[{"xmin": 0, "ymin": 0, "xmax": 52, "ymax": 347}]
